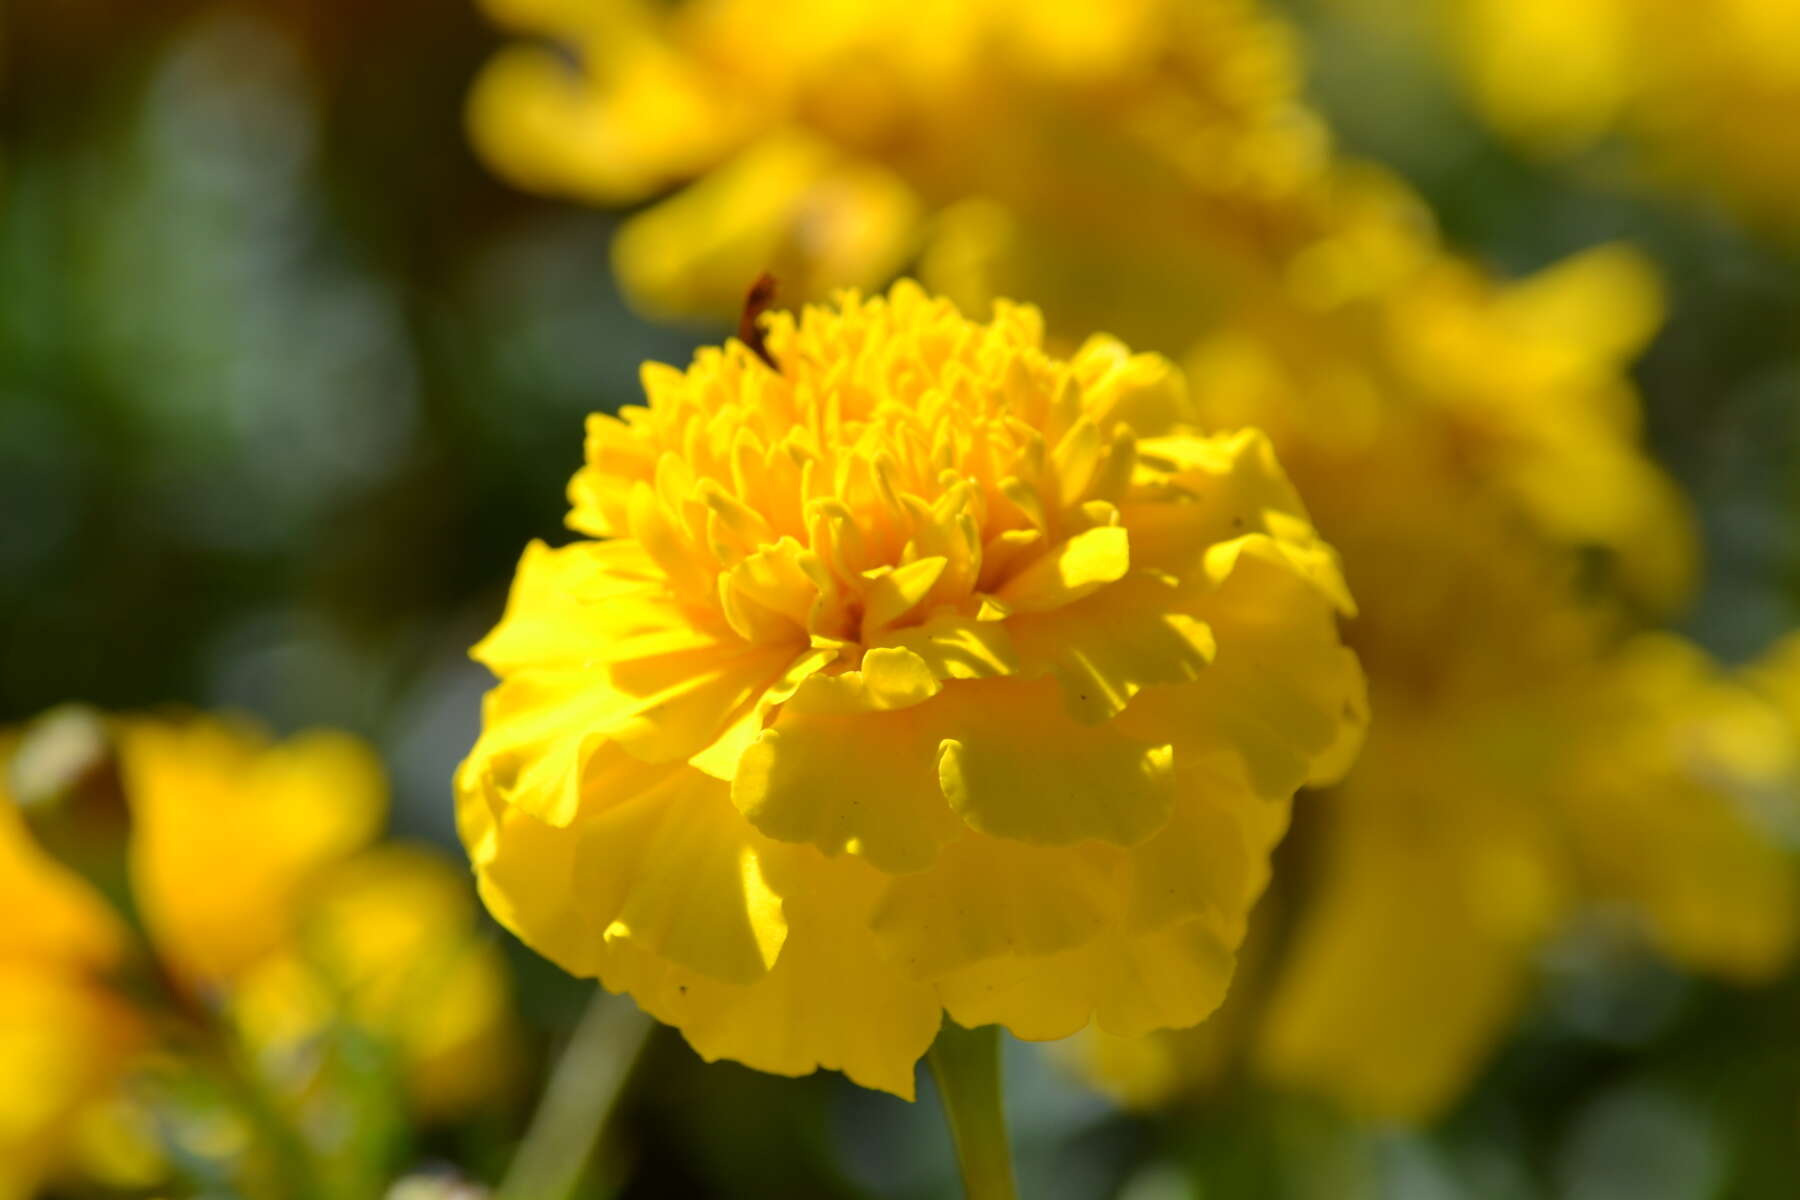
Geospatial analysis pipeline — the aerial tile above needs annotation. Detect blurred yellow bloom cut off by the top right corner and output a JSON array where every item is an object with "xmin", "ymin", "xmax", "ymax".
[{"xmin": 1433, "ymin": 0, "xmax": 1800, "ymax": 234}]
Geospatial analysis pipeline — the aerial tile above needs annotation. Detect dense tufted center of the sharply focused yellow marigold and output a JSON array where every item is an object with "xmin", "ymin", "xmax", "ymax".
[{"xmin": 571, "ymin": 290, "xmax": 1179, "ymax": 662}]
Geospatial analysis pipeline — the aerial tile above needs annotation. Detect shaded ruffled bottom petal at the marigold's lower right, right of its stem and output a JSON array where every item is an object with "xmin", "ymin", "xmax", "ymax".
[{"xmin": 896, "ymin": 761, "xmax": 1287, "ymax": 1040}]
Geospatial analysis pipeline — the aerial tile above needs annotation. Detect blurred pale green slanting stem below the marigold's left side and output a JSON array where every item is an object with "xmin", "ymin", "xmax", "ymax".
[{"xmin": 495, "ymin": 988, "xmax": 655, "ymax": 1200}]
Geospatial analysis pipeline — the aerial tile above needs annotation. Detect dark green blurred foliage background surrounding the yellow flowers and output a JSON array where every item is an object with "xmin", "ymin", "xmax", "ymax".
[{"xmin": 0, "ymin": 0, "xmax": 1800, "ymax": 1200}]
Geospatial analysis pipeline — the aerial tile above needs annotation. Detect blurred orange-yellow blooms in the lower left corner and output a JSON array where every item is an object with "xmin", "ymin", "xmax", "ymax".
[{"xmin": 0, "ymin": 718, "xmax": 515, "ymax": 1196}]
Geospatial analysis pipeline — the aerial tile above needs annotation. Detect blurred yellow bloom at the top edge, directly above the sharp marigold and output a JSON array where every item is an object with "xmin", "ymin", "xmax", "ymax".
[{"xmin": 470, "ymin": 0, "xmax": 1323, "ymax": 318}]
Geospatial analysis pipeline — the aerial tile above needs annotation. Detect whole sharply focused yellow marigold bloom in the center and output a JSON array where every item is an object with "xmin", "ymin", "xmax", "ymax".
[{"xmin": 457, "ymin": 282, "xmax": 1363, "ymax": 1096}]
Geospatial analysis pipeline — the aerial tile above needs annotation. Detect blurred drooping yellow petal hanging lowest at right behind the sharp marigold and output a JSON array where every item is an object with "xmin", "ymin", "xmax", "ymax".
[{"xmin": 1253, "ymin": 770, "xmax": 1561, "ymax": 1121}]
